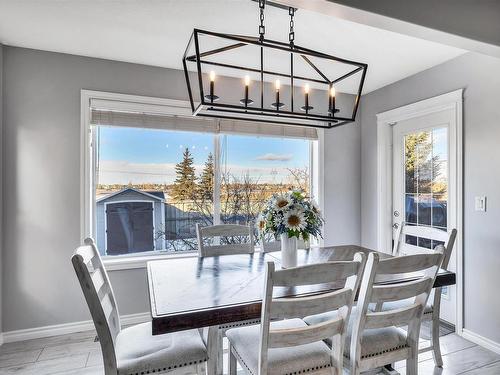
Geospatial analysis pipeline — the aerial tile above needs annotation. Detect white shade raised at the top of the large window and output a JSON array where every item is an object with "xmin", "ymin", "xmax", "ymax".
[{"xmin": 90, "ymin": 100, "xmax": 318, "ymax": 140}]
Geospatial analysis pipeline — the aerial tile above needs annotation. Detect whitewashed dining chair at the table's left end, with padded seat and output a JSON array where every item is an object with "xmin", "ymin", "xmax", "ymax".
[{"xmin": 71, "ymin": 238, "xmax": 207, "ymax": 375}]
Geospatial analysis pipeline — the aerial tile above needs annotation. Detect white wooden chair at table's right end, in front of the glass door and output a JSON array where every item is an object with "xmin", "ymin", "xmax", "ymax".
[{"xmin": 390, "ymin": 222, "xmax": 457, "ymax": 367}]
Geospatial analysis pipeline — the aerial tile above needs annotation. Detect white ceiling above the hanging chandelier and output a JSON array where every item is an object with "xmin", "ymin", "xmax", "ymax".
[{"xmin": 0, "ymin": 0, "xmax": 465, "ymax": 93}]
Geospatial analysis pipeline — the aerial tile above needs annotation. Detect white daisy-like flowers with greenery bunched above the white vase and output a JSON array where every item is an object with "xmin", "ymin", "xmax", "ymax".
[{"xmin": 257, "ymin": 190, "xmax": 324, "ymax": 241}]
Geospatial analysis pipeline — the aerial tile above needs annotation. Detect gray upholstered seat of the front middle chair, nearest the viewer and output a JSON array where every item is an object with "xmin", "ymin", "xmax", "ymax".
[{"xmin": 226, "ymin": 319, "xmax": 331, "ymax": 375}]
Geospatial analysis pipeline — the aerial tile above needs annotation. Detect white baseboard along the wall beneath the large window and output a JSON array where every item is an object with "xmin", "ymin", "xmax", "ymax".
[{"xmin": 0, "ymin": 312, "xmax": 151, "ymax": 345}]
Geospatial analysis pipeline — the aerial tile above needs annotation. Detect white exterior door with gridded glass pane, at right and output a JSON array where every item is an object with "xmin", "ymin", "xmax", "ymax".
[{"xmin": 392, "ymin": 110, "xmax": 457, "ymax": 324}]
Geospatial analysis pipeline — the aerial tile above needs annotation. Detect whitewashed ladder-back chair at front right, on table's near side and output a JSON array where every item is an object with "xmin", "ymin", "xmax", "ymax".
[{"xmin": 345, "ymin": 250, "xmax": 444, "ymax": 375}]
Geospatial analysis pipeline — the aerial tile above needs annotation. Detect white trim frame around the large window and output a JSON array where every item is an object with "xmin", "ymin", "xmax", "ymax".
[{"xmin": 80, "ymin": 89, "xmax": 324, "ymax": 271}]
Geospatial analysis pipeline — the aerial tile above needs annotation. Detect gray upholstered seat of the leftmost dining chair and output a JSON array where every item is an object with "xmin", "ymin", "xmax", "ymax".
[{"xmin": 116, "ymin": 323, "xmax": 207, "ymax": 375}]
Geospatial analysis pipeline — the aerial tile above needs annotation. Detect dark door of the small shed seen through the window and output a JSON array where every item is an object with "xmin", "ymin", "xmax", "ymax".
[{"xmin": 106, "ymin": 202, "xmax": 154, "ymax": 255}]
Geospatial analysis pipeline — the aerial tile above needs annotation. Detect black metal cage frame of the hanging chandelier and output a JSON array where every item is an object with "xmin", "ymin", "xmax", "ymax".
[{"xmin": 182, "ymin": 29, "xmax": 368, "ymax": 129}]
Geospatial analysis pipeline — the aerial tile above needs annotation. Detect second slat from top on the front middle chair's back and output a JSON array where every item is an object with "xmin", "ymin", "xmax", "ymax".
[{"xmin": 269, "ymin": 288, "xmax": 353, "ymax": 320}]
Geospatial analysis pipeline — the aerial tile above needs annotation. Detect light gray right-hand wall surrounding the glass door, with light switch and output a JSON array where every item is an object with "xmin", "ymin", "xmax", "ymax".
[{"xmin": 361, "ymin": 53, "xmax": 500, "ymax": 342}]
